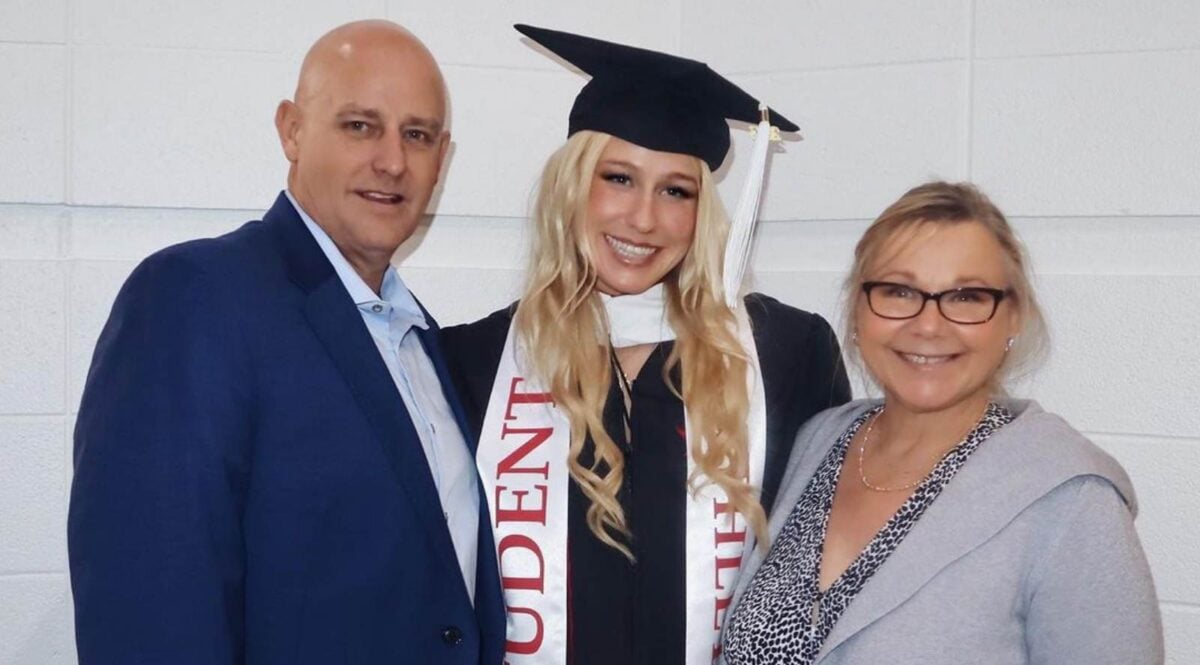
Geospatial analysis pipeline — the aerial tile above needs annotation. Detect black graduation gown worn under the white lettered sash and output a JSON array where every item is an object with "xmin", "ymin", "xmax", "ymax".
[{"xmin": 442, "ymin": 294, "xmax": 850, "ymax": 665}]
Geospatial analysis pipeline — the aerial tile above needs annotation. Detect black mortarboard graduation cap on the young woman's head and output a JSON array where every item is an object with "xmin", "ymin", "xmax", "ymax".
[{"xmin": 514, "ymin": 24, "xmax": 799, "ymax": 170}]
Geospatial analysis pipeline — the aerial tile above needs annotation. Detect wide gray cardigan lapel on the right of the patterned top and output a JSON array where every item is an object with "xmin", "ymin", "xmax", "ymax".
[{"xmin": 816, "ymin": 406, "xmax": 1132, "ymax": 663}]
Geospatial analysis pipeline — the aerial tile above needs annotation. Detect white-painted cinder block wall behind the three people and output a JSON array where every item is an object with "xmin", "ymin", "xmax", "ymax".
[{"xmin": 0, "ymin": 0, "xmax": 1200, "ymax": 665}]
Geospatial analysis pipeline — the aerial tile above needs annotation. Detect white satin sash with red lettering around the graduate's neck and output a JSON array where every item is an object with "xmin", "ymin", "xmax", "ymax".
[{"xmin": 475, "ymin": 301, "xmax": 767, "ymax": 665}]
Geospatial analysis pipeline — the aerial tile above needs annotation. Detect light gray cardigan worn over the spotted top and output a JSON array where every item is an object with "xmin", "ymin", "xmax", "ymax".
[{"xmin": 720, "ymin": 400, "xmax": 1163, "ymax": 665}]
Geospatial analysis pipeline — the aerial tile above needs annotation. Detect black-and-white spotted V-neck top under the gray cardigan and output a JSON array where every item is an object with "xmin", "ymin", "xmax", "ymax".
[{"xmin": 722, "ymin": 403, "xmax": 1013, "ymax": 665}]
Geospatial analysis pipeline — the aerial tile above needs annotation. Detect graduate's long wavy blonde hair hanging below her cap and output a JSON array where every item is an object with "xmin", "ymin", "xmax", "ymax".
[{"xmin": 515, "ymin": 131, "xmax": 766, "ymax": 559}]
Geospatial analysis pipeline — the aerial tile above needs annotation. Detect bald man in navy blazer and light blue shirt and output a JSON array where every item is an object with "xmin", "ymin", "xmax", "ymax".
[{"xmin": 68, "ymin": 22, "xmax": 504, "ymax": 665}]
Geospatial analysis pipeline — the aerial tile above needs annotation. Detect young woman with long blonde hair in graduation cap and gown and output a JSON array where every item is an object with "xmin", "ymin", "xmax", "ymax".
[{"xmin": 444, "ymin": 26, "xmax": 848, "ymax": 665}]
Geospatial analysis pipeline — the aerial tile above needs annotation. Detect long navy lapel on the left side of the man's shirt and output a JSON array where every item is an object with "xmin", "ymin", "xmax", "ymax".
[{"xmin": 264, "ymin": 193, "xmax": 456, "ymax": 562}]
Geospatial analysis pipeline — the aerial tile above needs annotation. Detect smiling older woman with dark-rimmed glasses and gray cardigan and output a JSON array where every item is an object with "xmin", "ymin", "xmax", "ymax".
[{"xmin": 722, "ymin": 182, "xmax": 1163, "ymax": 665}]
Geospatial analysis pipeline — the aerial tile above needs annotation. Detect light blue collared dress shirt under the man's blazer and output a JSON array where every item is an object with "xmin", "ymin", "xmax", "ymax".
[{"xmin": 287, "ymin": 192, "xmax": 479, "ymax": 603}]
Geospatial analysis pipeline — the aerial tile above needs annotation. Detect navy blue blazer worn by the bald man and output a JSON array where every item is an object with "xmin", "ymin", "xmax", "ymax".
[{"xmin": 68, "ymin": 194, "xmax": 504, "ymax": 665}]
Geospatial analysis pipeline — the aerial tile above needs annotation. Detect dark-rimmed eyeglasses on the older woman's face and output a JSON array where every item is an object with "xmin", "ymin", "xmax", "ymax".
[{"xmin": 863, "ymin": 282, "xmax": 1009, "ymax": 325}]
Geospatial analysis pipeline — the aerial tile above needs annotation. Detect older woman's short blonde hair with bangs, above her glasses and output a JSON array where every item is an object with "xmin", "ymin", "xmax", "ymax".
[{"xmin": 842, "ymin": 181, "xmax": 1049, "ymax": 394}]
